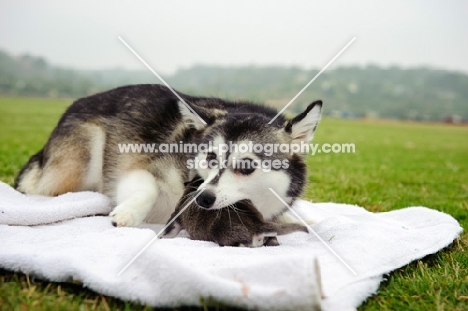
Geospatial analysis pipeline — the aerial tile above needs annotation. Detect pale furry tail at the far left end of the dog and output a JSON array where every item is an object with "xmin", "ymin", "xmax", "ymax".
[{"xmin": 14, "ymin": 150, "xmax": 44, "ymax": 194}]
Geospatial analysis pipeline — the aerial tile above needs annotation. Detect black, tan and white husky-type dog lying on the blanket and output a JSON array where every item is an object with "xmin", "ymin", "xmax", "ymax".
[{"xmin": 15, "ymin": 85, "xmax": 322, "ymax": 226}]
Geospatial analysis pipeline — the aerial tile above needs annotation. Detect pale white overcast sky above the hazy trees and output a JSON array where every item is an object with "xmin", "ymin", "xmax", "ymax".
[{"xmin": 0, "ymin": 0, "xmax": 468, "ymax": 73}]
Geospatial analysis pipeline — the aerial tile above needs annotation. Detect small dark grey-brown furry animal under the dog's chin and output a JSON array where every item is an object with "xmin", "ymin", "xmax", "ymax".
[{"xmin": 163, "ymin": 176, "xmax": 308, "ymax": 247}]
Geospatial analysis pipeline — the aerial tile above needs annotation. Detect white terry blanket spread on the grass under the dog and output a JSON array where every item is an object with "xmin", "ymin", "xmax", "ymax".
[{"xmin": 0, "ymin": 183, "xmax": 462, "ymax": 310}]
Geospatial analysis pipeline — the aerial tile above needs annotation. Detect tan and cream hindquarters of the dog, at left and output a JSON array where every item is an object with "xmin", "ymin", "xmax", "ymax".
[{"xmin": 15, "ymin": 123, "xmax": 105, "ymax": 196}]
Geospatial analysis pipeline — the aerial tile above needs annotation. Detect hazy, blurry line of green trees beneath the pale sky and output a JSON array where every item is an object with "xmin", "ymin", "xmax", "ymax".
[{"xmin": 0, "ymin": 50, "xmax": 468, "ymax": 120}]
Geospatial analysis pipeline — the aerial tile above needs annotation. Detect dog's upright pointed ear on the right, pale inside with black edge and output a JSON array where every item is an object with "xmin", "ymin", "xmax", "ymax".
[{"xmin": 284, "ymin": 100, "xmax": 322, "ymax": 144}]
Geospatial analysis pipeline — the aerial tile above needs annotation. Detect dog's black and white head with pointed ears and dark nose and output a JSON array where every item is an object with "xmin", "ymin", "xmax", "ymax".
[{"xmin": 180, "ymin": 101, "xmax": 322, "ymax": 219}]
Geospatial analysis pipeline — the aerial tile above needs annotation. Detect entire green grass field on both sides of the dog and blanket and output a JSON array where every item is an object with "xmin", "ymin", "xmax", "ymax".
[{"xmin": 0, "ymin": 98, "xmax": 468, "ymax": 310}]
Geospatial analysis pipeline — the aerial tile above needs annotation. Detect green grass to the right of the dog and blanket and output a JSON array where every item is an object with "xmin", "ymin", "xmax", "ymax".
[{"xmin": 306, "ymin": 120, "xmax": 468, "ymax": 310}]
